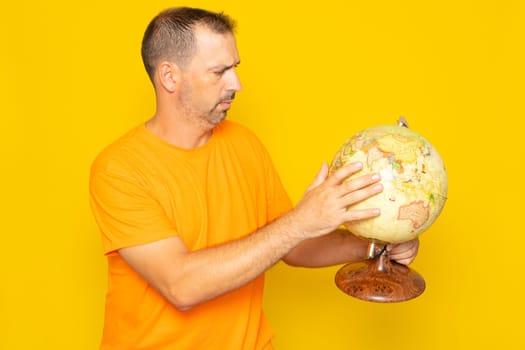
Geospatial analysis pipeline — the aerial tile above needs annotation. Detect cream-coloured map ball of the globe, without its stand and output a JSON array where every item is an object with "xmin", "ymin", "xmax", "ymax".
[{"xmin": 330, "ymin": 125, "xmax": 448, "ymax": 243}]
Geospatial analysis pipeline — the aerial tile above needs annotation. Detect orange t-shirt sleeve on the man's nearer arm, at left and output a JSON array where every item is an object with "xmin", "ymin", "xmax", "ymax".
[{"xmin": 90, "ymin": 163, "xmax": 177, "ymax": 254}]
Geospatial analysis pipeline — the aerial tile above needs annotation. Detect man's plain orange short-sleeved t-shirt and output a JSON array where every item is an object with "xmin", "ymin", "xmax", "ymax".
[{"xmin": 90, "ymin": 121, "xmax": 292, "ymax": 350}]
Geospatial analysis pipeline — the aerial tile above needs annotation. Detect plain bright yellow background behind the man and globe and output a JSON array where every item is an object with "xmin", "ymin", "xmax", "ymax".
[{"xmin": 0, "ymin": 0, "xmax": 525, "ymax": 350}]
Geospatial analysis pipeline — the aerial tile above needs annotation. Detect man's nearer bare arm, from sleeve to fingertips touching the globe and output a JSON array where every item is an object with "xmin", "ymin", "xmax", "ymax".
[{"xmin": 119, "ymin": 163, "xmax": 382, "ymax": 310}]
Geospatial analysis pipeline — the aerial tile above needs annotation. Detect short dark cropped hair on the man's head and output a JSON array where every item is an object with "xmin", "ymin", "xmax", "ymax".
[{"xmin": 142, "ymin": 7, "xmax": 235, "ymax": 81}]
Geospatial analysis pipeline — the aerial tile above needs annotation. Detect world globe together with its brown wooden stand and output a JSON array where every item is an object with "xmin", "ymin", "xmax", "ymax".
[{"xmin": 329, "ymin": 117, "xmax": 448, "ymax": 302}]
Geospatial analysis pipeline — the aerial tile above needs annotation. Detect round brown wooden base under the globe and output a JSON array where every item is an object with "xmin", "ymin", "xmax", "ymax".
[{"xmin": 335, "ymin": 250, "xmax": 425, "ymax": 303}]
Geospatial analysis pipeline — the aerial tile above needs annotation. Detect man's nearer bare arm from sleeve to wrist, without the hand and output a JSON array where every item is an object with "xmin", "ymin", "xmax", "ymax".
[{"xmin": 119, "ymin": 217, "xmax": 308, "ymax": 310}]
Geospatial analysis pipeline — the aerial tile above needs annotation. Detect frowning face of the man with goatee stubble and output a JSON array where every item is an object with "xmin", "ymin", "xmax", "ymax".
[{"xmin": 180, "ymin": 27, "xmax": 241, "ymax": 126}]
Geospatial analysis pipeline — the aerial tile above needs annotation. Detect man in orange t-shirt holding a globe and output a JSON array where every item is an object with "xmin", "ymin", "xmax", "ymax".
[{"xmin": 90, "ymin": 8, "xmax": 418, "ymax": 350}]
